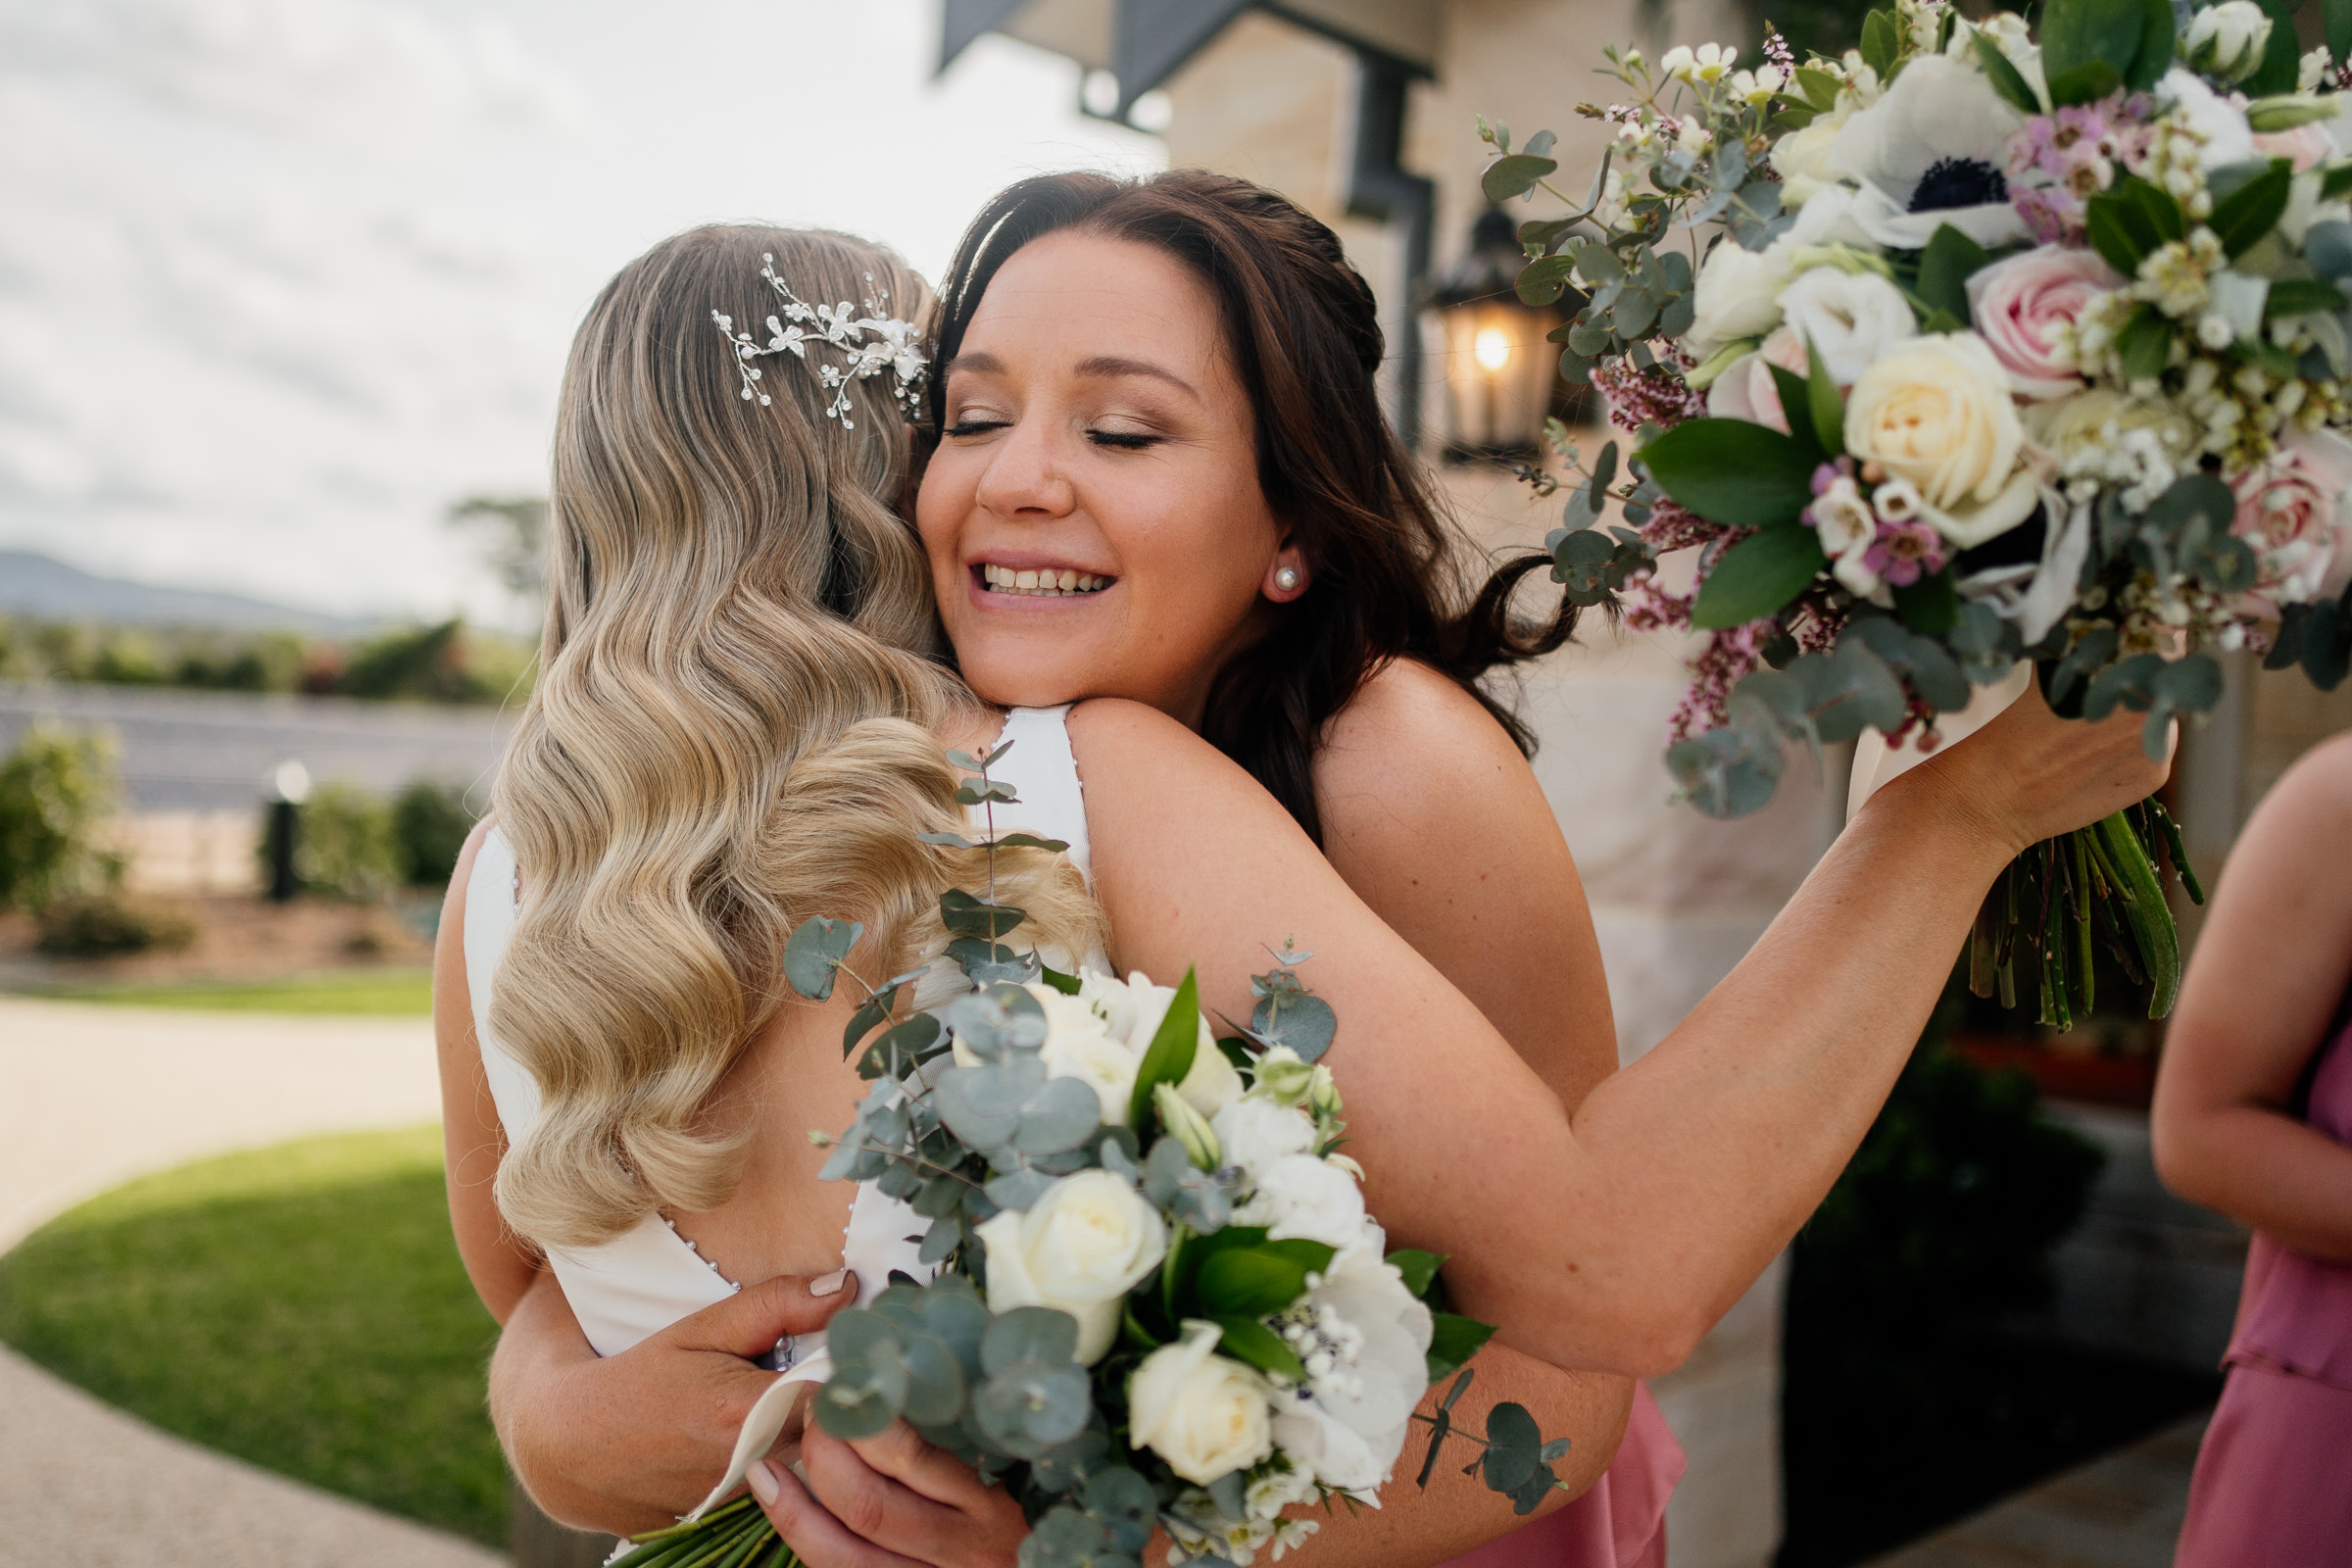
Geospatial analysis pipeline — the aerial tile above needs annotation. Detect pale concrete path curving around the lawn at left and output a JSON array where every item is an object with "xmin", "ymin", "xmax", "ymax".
[{"xmin": 0, "ymin": 997, "xmax": 506, "ymax": 1568}]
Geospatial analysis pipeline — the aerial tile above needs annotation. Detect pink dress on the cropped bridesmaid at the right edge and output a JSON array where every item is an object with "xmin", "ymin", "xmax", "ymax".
[{"xmin": 2174, "ymin": 1027, "xmax": 2352, "ymax": 1568}]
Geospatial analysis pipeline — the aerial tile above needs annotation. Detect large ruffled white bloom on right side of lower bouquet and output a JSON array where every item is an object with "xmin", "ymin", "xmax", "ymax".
[{"xmin": 1275, "ymin": 1227, "xmax": 1430, "ymax": 1491}]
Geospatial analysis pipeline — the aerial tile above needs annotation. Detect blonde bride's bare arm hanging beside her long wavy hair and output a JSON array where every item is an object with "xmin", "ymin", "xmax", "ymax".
[{"xmin": 433, "ymin": 818, "xmax": 541, "ymax": 1324}]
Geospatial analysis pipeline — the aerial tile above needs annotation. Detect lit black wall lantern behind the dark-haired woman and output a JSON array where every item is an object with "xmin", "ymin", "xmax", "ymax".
[{"xmin": 1430, "ymin": 207, "xmax": 1592, "ymax": 464}]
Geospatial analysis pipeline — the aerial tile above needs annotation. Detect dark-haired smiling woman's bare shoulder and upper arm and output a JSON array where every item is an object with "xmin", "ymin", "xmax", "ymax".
[{"xmin": 1300, "ymin": 661, "xmax": 1618, "ymax": 1109}]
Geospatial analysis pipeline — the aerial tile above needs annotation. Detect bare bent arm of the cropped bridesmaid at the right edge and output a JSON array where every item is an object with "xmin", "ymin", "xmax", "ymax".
[{"xmin": 2150, "ymin": 736, "xmax": 2352, "ymax": 1265}]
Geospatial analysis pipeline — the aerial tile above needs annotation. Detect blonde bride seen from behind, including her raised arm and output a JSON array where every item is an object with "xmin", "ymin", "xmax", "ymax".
[{"xmin": 437, "ymin": 230, "xmax": 2159, "ymax": 1568}]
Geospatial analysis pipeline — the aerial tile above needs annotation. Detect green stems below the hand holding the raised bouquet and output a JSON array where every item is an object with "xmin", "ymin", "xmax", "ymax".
[{"xmin": 1969, "ymin": 797, "xmax": 2204, "ymax": 1030}]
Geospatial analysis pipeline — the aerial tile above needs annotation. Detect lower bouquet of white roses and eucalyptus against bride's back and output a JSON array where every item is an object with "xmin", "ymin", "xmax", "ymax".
[{"xmin": 623, "ymin": 750, "xmax": 1566, "ymax": 1568}]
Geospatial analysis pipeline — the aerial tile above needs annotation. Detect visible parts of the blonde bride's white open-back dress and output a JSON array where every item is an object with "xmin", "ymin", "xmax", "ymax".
[{"xmin": 466, "ymin": 708, "xmax": 1103, "ymax": 1511}]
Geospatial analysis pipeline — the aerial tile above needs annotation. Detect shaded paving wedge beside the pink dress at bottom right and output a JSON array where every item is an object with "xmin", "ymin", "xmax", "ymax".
[{"xmin": 1870, "ymin": 1413, "xmax": 2211, "ymax": 1568}]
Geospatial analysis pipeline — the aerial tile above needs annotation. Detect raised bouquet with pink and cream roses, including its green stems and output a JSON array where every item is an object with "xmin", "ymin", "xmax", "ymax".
[{"xmin": 1482, "ymin": 0, "xmax": 2352, "ymax": 1025}]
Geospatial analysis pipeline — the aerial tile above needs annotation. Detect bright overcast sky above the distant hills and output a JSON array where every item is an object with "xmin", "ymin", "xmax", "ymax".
[{"xmin": 0, "ymin": 0, "xmax": 1162, "ymax": 615}]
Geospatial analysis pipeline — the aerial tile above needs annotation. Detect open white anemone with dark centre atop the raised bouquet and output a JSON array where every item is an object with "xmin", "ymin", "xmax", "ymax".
[{"xmin": 1823, "ymin": 54, "xmax": 2030, "ymax": 249}]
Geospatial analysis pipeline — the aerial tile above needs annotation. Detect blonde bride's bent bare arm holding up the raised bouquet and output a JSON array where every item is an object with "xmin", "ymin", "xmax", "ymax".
[{"xmin": 1070, "ymin": 696, "xmax": 2164, "ymax": 1375}]
